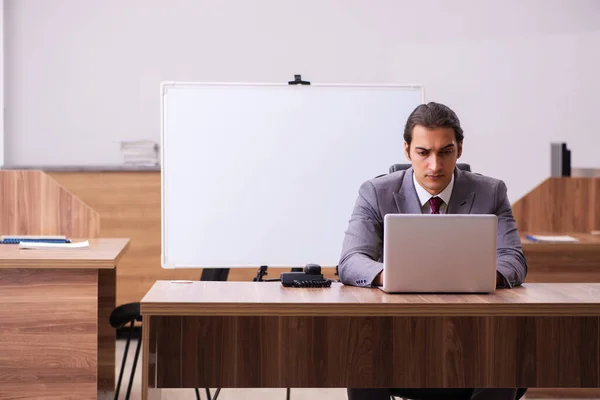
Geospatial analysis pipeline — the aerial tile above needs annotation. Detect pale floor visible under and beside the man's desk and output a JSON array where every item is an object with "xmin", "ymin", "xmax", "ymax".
[{"xmin": 115, "ymin": 340, "xmax": 600, "ymax": 400}]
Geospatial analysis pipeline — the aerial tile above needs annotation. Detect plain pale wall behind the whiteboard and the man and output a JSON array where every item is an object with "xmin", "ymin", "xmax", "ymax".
[{"xmin": 4, "ymin": 0, "xmax": 600, "ymax": 201}]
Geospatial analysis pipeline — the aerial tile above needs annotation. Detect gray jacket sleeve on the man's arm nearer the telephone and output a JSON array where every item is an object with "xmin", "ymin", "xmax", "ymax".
[{"xmin": 338, "ymin": 182, "xmax": 383, "ymax": 286}]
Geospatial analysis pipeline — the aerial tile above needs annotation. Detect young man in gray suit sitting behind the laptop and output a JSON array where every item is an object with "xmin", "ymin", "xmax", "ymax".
[{"xmin": 339, "ymin": 102, "xmax": 527, "ymax": 400}]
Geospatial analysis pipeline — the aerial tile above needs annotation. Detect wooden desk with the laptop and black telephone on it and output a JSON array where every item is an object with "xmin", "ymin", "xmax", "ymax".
[{"xmin": 141, "ymin": 281, "xmax": 600, "ymax": 399}]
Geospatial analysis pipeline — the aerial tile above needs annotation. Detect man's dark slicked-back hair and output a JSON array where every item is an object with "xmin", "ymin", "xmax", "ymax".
[{"xmin": 404, "ymin": 102, "xmax": 464, "ymax": 147}]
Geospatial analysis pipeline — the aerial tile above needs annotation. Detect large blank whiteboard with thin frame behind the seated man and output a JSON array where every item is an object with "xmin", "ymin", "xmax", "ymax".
[{"xmin": 161, "ymin": 82, "xmax": 424, "ymax": 268}]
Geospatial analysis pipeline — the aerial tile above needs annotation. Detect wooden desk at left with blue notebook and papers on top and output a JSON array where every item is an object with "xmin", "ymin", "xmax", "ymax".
[{"xmin": 0, "ymin": 239, "xmax": 129, "ymax": 399}]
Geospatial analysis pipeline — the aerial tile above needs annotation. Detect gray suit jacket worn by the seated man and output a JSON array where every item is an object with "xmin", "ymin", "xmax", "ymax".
[{"xmin": 338, "ymin": 168, "xmax": 527, "ymax": 287}]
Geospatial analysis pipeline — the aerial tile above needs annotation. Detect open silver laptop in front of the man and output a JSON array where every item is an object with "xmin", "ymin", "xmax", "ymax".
[{"xmin": 382, "ymin": 214, "xmax": 498, "ymax": 293}]
